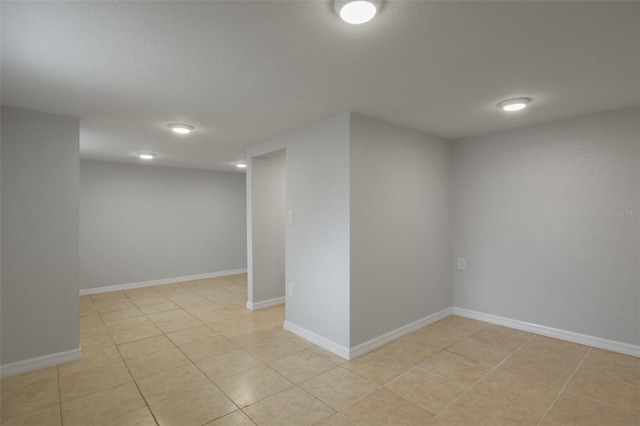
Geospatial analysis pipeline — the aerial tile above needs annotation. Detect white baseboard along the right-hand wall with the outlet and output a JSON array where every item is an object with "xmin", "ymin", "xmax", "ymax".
[{"xmin": 453, "ymin": 307, "xmax": 640, "ymax": 357}]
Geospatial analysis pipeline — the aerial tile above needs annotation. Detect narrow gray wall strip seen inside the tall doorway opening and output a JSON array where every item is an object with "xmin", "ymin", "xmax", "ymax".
[{"xmin": 249, "ymin": 150, "xmax": 286, "ymax": 303}]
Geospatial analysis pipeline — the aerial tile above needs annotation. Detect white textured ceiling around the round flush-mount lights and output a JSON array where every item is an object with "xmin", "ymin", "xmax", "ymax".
[{"xmin": 0, "ymin": 0, "xmax": 640, "ymax": 170}]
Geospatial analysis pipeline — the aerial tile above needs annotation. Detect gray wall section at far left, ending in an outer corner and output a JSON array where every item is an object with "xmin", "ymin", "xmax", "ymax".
[{"xmin": 0, "ymin": 106, "xmax": 79, "ymax": 364}]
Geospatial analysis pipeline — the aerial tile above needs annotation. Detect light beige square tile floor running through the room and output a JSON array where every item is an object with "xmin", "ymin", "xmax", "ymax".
[{"xmin": 0, "ymin": 275, "xmax": 640, "ymax": 426}]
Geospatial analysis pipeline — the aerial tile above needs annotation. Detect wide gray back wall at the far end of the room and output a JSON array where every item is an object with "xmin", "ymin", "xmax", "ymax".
[{"xmin": 80, "ymin": 160, "xmax": 246, "ymax": 289}]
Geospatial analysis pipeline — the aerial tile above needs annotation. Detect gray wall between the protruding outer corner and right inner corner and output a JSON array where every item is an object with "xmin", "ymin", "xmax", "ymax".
[{"xmin": 350, "ymin": 114, "xmax": 452, "ymax": 347}]
